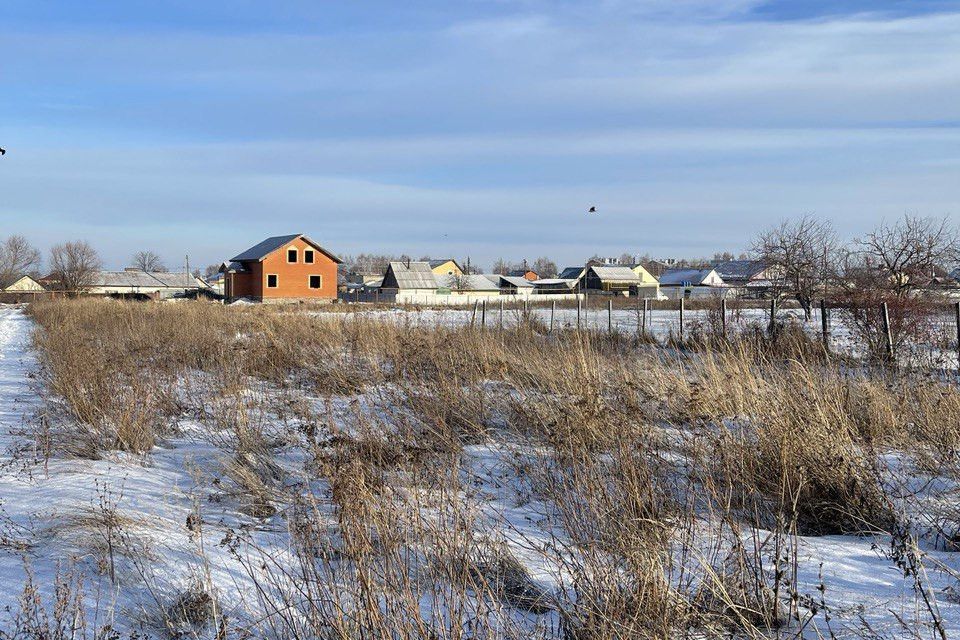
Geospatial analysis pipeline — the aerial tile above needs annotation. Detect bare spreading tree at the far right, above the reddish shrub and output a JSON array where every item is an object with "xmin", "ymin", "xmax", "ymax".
[{"xmin": 855, "ymin": 215, "xmax": 960, "ymax": 298}]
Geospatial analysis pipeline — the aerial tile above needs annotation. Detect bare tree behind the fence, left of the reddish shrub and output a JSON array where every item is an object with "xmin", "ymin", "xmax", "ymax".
[{"xmin": 753, "ymin": 215, "xmax": 837, "ymax": 320}]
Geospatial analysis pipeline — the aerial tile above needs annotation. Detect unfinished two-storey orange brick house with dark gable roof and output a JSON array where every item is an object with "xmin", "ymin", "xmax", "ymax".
[{"xmin": 221, "ymin": 233, "xmax": 340, "ymax": 302}]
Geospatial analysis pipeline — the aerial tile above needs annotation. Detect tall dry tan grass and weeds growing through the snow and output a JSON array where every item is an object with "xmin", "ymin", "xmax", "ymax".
[{"xmin": 16, "ymin": 300, "xmax": 960, "ymax": 640}]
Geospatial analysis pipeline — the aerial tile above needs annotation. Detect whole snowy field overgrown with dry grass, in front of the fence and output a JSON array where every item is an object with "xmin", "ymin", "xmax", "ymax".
[{"xmin": 0, "ymin": 300, "xmax": 960, "ymax": 640}]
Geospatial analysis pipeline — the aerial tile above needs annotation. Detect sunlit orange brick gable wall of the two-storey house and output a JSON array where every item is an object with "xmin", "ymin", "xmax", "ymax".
[{"xmin": 258, "ymin": 238, "xmax": 337, "ymax": 301}]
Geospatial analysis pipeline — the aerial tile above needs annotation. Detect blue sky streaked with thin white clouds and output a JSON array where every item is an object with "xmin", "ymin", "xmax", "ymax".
[{"xmin": 0, "ymin": 0, "xmax": 960, "ymax": 268}]
